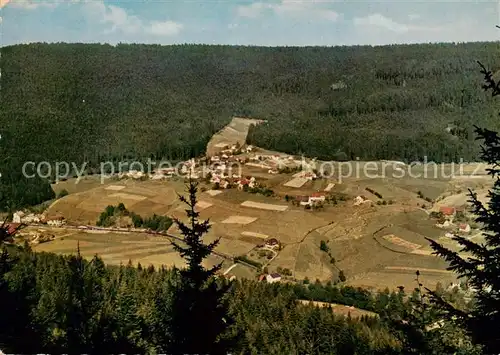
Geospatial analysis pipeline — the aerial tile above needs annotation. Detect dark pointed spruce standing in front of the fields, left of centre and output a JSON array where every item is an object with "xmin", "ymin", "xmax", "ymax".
[{"xmin": 166, "ymin": 179, "xmax": 230, "ymax": 354}]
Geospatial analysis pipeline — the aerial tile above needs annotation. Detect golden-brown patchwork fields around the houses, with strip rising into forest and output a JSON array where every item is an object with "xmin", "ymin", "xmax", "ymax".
[{"xmin": 41, "ymin": 118, "xmax": 491, "ymax": 289}]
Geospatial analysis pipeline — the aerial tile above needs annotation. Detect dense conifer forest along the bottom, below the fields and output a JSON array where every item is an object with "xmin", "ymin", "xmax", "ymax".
[{"xmin": 0, "ymin": 249, "xmax": 458, "ymax": 355}]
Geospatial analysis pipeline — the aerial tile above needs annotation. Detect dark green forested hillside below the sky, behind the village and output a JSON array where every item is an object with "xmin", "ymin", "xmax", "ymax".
[{"xmin": 0, "ymin": 43, "xmax": 500, "ymax": 163}]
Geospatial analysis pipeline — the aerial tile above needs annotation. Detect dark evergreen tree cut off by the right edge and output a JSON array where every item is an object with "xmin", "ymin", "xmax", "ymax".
[{"xmin": 427, "ymin": 63, "xmax": 500, "ymax": 354}]
